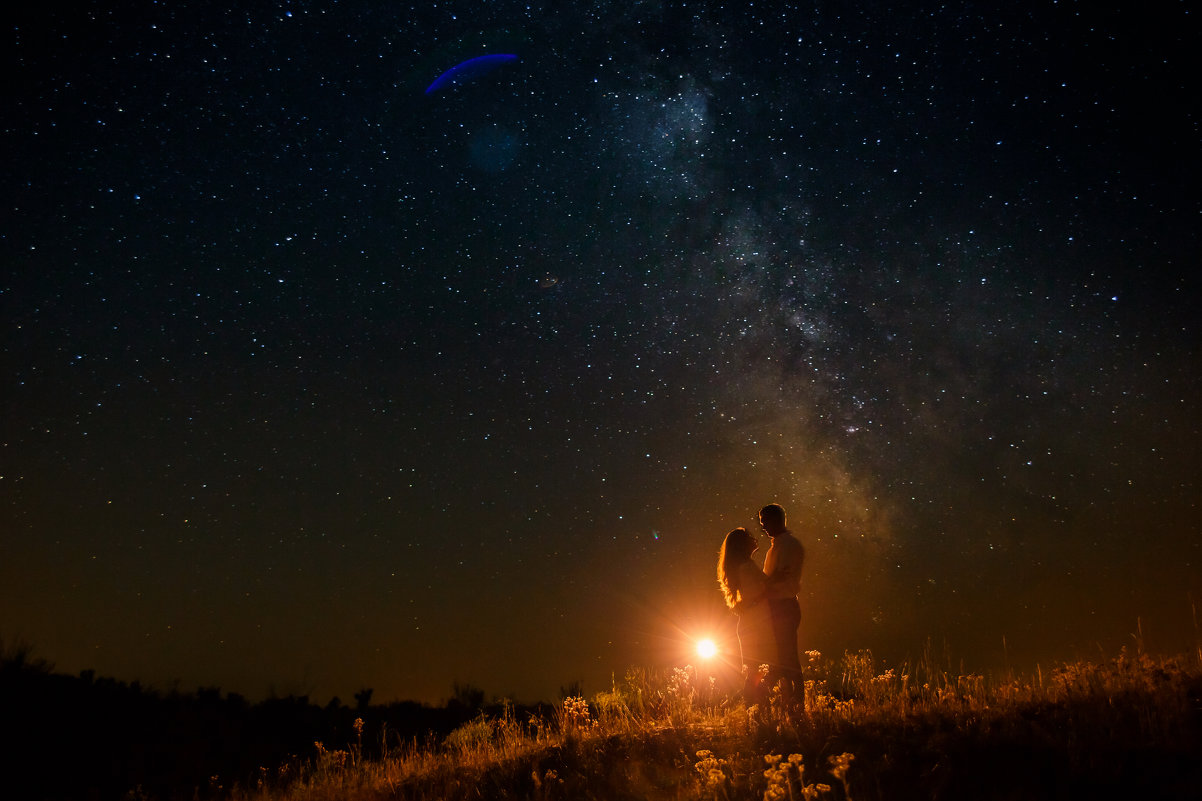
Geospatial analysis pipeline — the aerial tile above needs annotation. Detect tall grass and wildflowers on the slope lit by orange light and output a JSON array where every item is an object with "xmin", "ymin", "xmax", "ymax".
[{"xmin": 224, "ymin": 648, "xmax": 1202, "ymax": 801}]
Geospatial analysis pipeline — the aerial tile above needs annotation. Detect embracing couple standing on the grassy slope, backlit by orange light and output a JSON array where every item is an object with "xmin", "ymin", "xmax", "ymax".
[{"xmin": 718, "ymin": 504, "xmax": 805, "ymax": 711}]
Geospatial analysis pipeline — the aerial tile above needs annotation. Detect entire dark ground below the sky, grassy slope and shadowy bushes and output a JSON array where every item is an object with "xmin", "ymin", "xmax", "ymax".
[{"xmin": 0, "ymin": 647, "xmax": 1202, "ymax": 801}]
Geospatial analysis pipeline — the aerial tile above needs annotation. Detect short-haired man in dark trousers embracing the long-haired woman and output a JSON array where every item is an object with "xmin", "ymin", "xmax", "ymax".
[{"xmin": 760, "ymin": 504, "xmax": 805, "ymax": 711}]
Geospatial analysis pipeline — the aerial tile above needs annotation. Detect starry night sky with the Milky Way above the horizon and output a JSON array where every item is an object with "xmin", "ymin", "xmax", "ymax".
[{"xmin": 7, "ymin": 0, "xmax": 1202, "ymax": 702}]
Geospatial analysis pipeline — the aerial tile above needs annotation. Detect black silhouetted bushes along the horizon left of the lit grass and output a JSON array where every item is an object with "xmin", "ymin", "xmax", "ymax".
[{"xmin": 0, "ymin": 647, "xmax": 536, "ymax": 801}]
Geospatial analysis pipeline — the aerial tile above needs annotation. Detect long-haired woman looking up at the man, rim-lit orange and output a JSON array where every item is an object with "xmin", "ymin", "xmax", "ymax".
[{"xmin": 718, "ymin": 527, "xmax": 776, "ymax": 704}]
